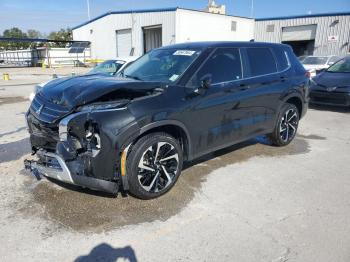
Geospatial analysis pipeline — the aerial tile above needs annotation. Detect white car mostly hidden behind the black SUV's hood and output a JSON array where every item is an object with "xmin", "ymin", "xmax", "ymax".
[{"xmin": 29, "ymin": 56, "xmax": 138, "ymax": 101}]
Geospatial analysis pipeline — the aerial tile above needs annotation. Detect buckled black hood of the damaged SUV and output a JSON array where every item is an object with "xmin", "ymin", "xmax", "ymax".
[{"xmin": 40, "ymin": 74, "xmax": 162, "ymax": 108}]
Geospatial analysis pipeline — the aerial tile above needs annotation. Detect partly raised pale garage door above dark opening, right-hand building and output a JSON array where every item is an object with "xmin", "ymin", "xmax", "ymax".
[{"xmin": 282, "ymin": 25, "xmax": 317, "ymax": 41}]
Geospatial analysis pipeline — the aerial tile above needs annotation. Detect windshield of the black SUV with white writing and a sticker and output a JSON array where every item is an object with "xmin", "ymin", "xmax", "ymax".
[{"xmin": 120, "ymin": 48, "xmax": 201, "ymax": 83}]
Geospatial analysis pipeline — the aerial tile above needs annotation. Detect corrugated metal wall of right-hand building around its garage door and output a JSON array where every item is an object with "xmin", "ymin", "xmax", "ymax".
[{"xmin": 255, "ymin": 15, "xmax": 350, "ymax": 56}]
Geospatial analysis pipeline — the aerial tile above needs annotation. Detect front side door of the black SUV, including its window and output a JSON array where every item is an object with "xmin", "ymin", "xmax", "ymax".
[{"xmin": 185, "ymin": 48, "xmax": 247, "ymax": 156}]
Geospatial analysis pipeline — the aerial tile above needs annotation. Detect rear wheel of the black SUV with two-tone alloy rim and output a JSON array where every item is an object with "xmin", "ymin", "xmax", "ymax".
[{"xmin": 268, "ymin": 103, "xmax": 300, "ymax": 146}]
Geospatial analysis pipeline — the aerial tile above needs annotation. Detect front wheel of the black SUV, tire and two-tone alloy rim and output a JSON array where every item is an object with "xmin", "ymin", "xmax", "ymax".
[{"xmin": 126, "ymin": 133, "xmax": 183, "ymax": 199}]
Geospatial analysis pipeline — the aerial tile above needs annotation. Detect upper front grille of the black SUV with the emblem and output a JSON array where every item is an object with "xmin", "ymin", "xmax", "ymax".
[{"xmin": 30, "ymin": 94, "xmax": 70, "ymax": 123}]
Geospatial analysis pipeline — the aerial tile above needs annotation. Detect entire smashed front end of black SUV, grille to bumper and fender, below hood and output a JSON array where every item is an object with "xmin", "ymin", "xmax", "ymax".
[{"xmin": 25, "ymin": 79, "xmax": 163, "ymax": 194}]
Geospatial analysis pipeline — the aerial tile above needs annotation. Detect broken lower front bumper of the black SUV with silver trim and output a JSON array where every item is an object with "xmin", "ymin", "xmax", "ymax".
[{"xmin": 25, "ymin": 150, "xmax": 118, "ymax": 194}]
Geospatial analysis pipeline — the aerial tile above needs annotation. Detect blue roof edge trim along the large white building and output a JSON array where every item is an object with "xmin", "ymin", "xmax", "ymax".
[{"xmin": 72, "ymin": 7, "xmax": 252, "ymax": 30}]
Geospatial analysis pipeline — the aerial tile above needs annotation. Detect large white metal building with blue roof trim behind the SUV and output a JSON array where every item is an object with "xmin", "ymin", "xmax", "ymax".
[{"xmin": 73, "ymin": 8, "xmax": 254, "ymax": 59}]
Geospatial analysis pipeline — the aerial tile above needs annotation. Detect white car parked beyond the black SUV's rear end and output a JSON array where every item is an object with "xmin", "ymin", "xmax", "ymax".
[{"xmin": 301, "ymin": 55, "xmax": 340, "ymax": 77}]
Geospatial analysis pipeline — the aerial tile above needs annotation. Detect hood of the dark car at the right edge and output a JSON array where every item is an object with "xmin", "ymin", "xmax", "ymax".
[{"xmin": 314, "ymin": 72, "xmax": 350, "ymax": 87}]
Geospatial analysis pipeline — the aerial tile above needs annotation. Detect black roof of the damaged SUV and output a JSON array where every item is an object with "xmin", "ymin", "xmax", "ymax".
[{"xmin": 159, "ymin": 41, "xmax": 285, "ymax": 49}]
